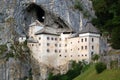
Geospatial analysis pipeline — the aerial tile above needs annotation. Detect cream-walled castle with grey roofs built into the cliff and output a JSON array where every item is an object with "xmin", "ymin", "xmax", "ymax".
[{"xmin": 28, "ymin": 20, "xmax": 100, "ymax": 67}]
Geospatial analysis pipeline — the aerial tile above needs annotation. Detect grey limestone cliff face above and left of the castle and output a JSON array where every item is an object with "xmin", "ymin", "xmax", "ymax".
[{"xmin": 0, "ymin": 0, "xmax": 95, "ymax": 80}]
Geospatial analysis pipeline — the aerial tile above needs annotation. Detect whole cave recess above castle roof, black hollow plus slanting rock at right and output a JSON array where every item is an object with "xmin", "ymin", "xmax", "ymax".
[{"xmin": 26, "ymin": 3, "xmax": 73, "ymax": 32}]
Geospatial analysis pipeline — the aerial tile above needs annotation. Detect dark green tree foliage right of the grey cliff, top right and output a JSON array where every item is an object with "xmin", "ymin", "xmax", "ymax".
[{"xmin": 92, "ymin": 0, "xmax": 120, "ymax": 49}]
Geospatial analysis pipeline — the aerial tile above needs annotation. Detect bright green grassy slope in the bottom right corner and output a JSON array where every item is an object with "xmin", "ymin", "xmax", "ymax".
[{"xmin": 73, "ymin": 65, "xmax": 120, "ymax": 80}]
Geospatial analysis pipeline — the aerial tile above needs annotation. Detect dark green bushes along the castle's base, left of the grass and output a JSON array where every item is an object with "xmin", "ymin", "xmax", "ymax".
[{"xmin": 48, "ymin": 61, "xmax": 88, "ymax": 80}]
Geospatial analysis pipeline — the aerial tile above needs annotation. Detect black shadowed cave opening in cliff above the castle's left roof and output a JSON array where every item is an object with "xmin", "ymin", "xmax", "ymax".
[{"xmin": 27, "ymin": 3, "xmax": 45, "ymax": 22}]
